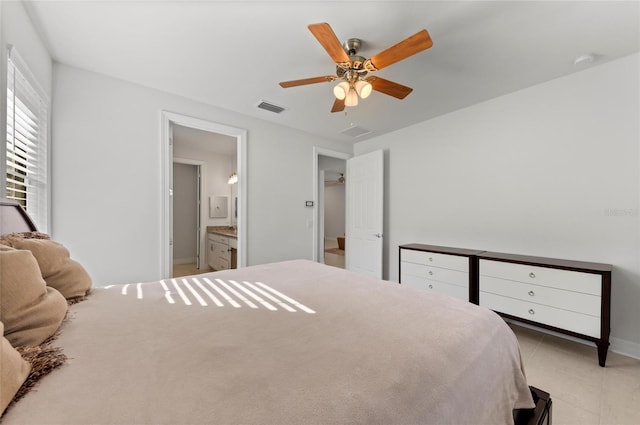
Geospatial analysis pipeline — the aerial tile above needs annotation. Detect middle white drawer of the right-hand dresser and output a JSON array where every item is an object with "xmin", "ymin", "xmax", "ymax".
[{"xmin": 480, "ymin": 276, "xmax": 602, "ymax": 317}]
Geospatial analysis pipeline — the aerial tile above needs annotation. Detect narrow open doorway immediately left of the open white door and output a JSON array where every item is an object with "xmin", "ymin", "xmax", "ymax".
[{"xmin": 313, "ymin": 148, "xmax": 351, "ymax": 268}]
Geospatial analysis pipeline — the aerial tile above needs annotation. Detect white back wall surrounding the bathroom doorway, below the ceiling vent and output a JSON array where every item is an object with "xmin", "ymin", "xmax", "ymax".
[{"xmin": 52, "ymin": 64, "xmax": 351, "ymax": 285}]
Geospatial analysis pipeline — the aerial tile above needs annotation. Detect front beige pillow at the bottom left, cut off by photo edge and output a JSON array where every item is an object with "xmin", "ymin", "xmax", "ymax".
[{"xmin": 0, "ymin": 322, "xmax": 31, "ymax": 415}]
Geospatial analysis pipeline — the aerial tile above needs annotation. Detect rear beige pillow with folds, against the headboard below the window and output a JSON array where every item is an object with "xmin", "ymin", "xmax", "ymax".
[{"xmin": 4, "ymin": 233, "xmax": 91, "ymax": 299}]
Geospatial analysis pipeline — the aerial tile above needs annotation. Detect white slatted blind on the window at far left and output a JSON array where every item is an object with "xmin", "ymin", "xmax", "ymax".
[{"xmin": 5, "ymin": 47, "xmax": 49, "ymax": 232}]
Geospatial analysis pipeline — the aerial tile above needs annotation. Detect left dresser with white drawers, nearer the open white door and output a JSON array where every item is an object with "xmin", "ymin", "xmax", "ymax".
[{"xmin": 399, "ymin": 244, "xmax": 481, "ymax": 303}]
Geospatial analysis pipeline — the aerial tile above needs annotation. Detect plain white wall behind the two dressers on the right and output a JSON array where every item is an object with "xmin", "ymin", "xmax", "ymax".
[{"xmin": 354, "ymin": 54, "xmax": 640, "ymax": 355}]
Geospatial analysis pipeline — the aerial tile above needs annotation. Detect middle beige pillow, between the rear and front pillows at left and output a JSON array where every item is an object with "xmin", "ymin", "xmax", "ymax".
[{"xmin": 0, "ymin": 249, "xmax": 67, "ymax": 347}]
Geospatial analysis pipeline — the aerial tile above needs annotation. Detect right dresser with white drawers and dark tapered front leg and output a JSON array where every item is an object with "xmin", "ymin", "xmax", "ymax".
[{"xmin": 478, "ymin": 251, "xmax": 612, "ymax": 366}]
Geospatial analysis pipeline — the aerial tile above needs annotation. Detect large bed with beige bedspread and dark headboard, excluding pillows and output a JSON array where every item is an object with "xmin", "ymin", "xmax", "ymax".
[{"xmin": 0, "ymin": 201, "xmax": 536, "ymax": 424}]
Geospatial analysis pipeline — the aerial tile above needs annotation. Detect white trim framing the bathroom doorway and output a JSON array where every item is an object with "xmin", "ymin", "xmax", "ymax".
[{"xmin": 160, "ymin": 111, "xmax": 247, "ymax": 278}]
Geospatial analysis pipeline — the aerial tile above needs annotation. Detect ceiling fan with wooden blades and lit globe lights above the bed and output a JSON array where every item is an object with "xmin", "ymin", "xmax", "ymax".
[{"xmin": 280, "ymin": 22, "xmax": 433, "ymax": 112}]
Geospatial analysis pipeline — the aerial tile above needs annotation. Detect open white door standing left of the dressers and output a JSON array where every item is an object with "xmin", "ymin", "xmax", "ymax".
[{"xmin": 345, "ymin": 150, "xmax": 384, "ymax": 279}]
